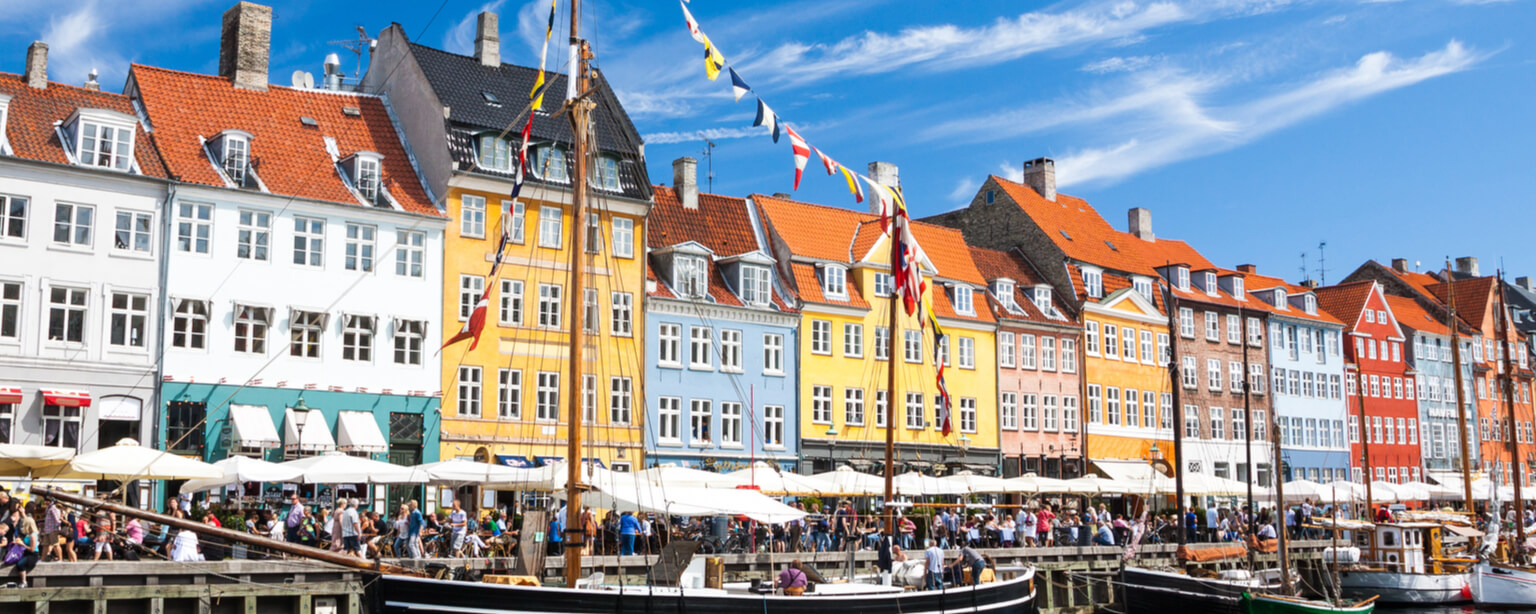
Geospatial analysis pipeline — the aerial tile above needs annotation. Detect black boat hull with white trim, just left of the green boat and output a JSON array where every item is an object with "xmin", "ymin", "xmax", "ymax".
[{"xmin": 1120, "ymin": 566, "xmax": 1261, "ymax": 614}]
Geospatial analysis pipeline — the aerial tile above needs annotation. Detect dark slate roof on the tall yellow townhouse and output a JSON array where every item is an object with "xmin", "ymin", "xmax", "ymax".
[{"xmin": 410, "ymin": 43, "xmax": 651, "ymax": 200}]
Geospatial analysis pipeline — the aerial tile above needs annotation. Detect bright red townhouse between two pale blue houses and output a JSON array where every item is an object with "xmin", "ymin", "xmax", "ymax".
[{"xmin": 1316, "ymin": 279, "xmax": 1424, "ymax": 484}]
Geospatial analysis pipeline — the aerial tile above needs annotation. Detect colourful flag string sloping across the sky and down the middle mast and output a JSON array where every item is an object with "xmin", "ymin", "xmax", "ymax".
[{"xmin": 677, "ymin": 0, "xmax": 951, "ymax": 426}]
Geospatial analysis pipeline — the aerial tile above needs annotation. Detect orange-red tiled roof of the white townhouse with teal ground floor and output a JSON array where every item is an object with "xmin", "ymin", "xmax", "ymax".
[{"xmin": 131, "ymin": 64, "xmax": 444, "ymax": 215}]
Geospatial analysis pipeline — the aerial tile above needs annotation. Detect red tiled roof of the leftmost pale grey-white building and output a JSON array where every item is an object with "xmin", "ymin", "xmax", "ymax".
[{"xmin": 0, "ymin": 72, "xmax": 169, "ymax": 178}]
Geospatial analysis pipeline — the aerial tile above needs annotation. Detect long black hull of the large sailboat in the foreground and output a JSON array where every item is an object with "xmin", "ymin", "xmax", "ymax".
[{"xmin": 373, "ymin": 568, "xmax": 1035, "ymax": 614}]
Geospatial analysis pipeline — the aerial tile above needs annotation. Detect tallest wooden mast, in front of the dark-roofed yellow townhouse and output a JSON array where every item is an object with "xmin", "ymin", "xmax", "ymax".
[{"xmin": 561, "ymin": 0, "xmax": 591, "ymax": 588}]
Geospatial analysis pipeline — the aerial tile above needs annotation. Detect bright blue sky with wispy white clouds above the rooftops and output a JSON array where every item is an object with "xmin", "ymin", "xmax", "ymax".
[{"xmin": 0, "ymin": 0, "xmax": 1536, "ymax": 281}]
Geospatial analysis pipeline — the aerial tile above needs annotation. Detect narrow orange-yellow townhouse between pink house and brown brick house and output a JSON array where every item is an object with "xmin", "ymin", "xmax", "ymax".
[{"xmin": 928, "ymin": 158, "xmax": 1177, "ymax": 485}]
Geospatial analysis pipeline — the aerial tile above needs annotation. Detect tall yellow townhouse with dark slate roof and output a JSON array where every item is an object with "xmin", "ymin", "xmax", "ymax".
[{"xmin": 362, "ymin": 12, "xmax": 651, "ymax": 471}]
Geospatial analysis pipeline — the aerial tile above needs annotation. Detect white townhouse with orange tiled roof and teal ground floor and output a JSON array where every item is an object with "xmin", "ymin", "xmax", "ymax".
[{"xmin": 124, "ymin": 3, "xmax": 445, "ymax": 503}]
